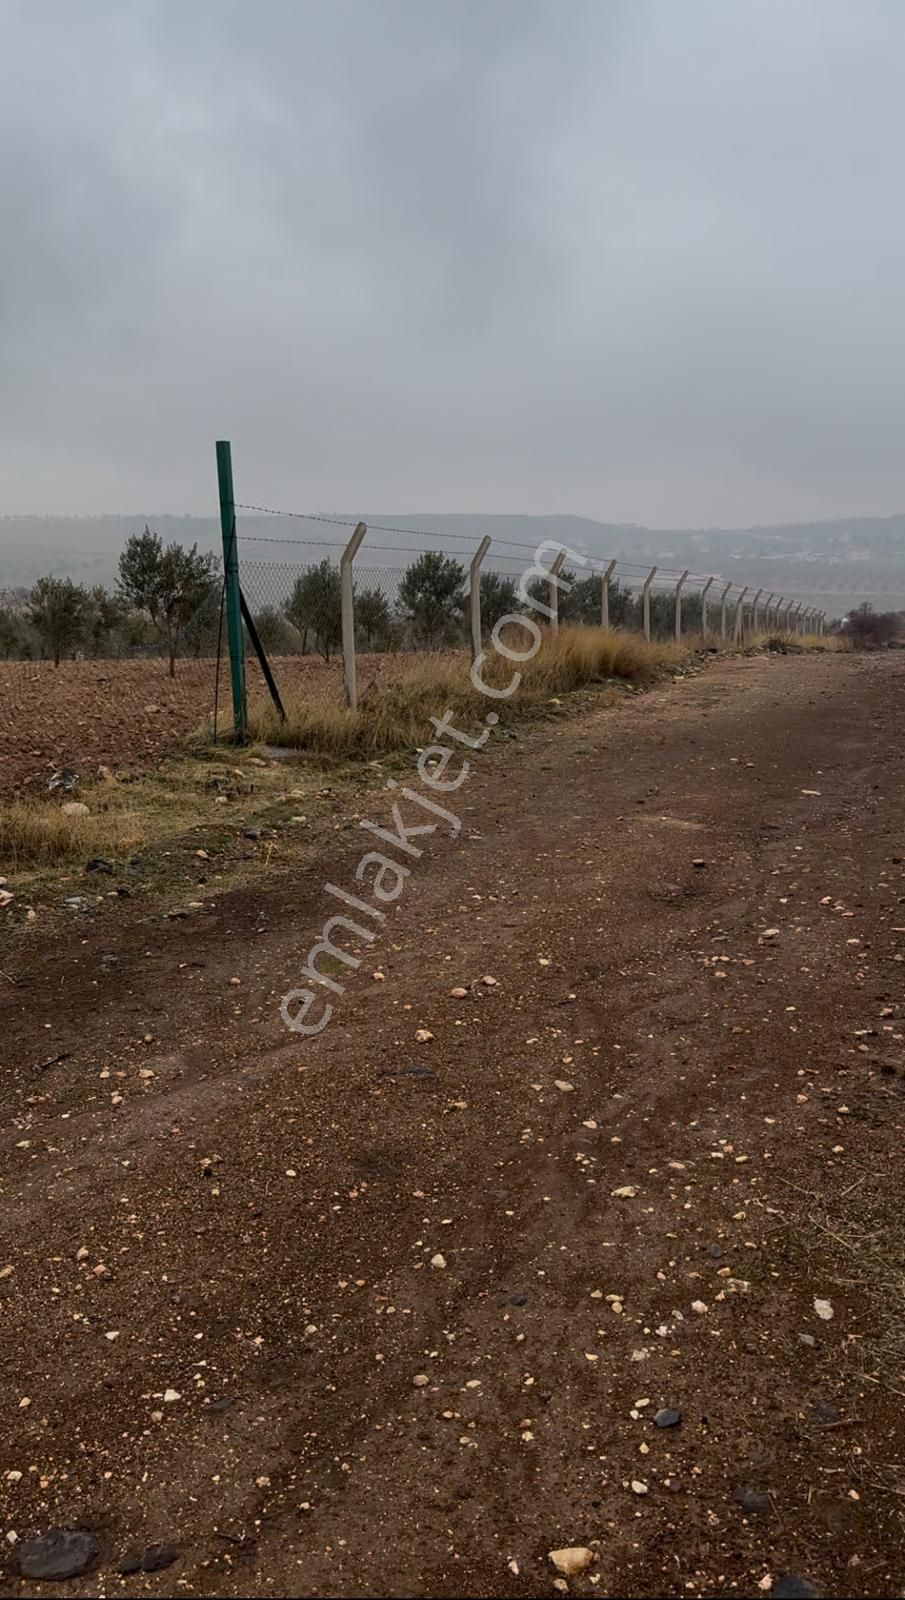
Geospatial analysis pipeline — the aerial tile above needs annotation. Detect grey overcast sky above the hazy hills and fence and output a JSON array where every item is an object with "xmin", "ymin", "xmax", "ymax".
[{"xmin": 0, "ymin": 0, "xmax": 905, "ymax": 526}]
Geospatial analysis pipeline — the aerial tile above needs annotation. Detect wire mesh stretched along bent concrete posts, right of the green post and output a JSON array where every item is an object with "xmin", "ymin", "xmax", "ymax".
[{"xmin": 227, "ymin": 507, "xmax": 837, "ymax": 732}]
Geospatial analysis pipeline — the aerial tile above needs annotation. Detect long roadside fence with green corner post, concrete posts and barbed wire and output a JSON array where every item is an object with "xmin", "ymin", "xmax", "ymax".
[{"xmin": 217, "ymin": 425, "xmax": 825, "ymax": 736}]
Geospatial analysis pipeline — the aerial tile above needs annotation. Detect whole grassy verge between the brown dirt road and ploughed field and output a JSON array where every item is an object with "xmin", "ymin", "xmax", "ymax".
[{"xmin": 0, "ymin": 627, "xmax": 846, "ymax": 902}]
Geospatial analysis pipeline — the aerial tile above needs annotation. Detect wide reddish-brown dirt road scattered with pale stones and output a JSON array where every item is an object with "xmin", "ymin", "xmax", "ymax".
[{"xmin": 0, "ymin": 656, "xmax": 905, "ymax": 1597}]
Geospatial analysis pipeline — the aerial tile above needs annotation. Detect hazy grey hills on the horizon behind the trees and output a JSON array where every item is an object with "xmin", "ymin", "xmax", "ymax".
[{"xmin": 0, "ymin": 512, "xmax": 905, "ymax": 614}]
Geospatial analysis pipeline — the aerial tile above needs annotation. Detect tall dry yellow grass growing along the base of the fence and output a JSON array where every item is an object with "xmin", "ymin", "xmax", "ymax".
[{"xmin": 249, "ymin": 627, "xmax": 692, "ymax": 755}]
